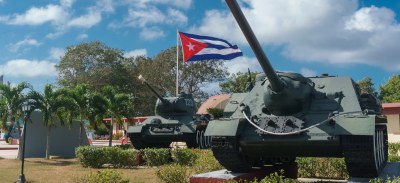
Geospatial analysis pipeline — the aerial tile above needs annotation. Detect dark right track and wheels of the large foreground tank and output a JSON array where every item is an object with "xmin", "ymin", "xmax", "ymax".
[{"xmin": 342, "ymin": 125, "xmax": 388, "ymax": 178}]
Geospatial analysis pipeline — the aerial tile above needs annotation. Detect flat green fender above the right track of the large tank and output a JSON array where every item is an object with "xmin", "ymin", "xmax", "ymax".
[{"xmin": 335, "ymin": 115, "xmax": 384, "ymax": 136}]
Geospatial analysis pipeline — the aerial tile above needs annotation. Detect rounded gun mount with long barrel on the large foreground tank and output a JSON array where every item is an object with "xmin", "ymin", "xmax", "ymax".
[{"xmin": 226, "ymin": 0, "xmax": 313, "ymax": 115}]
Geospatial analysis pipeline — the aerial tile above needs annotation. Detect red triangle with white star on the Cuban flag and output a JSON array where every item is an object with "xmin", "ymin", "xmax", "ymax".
[{"xmin": 179, "ymin": 32, "xmax": 208, "ymax": 62}]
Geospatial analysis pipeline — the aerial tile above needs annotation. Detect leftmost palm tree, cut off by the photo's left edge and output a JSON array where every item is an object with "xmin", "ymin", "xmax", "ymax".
[{"xmin": 0, "ymin": 82, "xmax": 32, "ymax": 134}]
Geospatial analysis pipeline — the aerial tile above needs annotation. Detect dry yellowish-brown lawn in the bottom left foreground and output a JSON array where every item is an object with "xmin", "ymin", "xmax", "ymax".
[{"xmin": 0, "ymin": 158, "xmax": 160, "ymax": 183}]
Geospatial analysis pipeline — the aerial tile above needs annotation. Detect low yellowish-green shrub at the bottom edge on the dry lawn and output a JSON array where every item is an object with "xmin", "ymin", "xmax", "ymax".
[{"xmin": 79, "ymin": 170, "xmax": 129, "ymax": 183}]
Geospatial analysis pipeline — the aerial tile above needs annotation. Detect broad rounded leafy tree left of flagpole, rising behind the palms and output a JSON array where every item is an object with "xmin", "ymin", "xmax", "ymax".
[{"xmin": 56, "ymin": 41, "xmax": 133, "ymax": 91}]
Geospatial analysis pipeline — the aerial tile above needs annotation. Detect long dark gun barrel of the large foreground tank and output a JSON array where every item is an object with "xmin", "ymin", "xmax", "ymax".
[{"xmin": 225, "ymin": 0, "xmax": 284, "ymax": 92}]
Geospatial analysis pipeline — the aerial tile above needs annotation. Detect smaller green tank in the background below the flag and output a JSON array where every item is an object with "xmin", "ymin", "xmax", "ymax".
[{"xmin": 127, "ymin": 76, "xmax": 211, "ymax": 149}]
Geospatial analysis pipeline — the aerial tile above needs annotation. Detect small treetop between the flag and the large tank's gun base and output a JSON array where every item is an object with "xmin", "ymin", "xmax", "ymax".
[{"xmin": 219, "ymin": 72, "xmax": 257, "ymax": 93}]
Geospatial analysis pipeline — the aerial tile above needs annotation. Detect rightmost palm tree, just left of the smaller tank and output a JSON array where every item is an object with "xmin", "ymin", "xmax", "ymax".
[{"xmin": 102, "ymin": 86, "xmax": 133, "ymax": 146}]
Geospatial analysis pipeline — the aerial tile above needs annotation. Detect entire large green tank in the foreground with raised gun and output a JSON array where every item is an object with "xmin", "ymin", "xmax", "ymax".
[{"xmin": 205, "ymin": 0, "xmax": 388, "ymax": 177}]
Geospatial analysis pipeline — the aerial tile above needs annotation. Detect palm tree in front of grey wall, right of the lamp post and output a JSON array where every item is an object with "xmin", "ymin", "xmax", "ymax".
[{"xmin": 27, "ymin": 84, "xmax": 74, "ymax": 159}]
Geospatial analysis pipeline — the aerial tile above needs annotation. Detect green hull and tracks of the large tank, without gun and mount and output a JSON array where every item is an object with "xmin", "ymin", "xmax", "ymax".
[{"xmin": 205, "ymin": 77, "xmax": 388, "ymax": 177}]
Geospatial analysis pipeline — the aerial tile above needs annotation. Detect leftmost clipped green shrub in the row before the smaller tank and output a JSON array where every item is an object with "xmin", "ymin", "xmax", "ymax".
[{"xmin": 75, "ymin": 146, "xmax": 108, "ymax": 168}]
